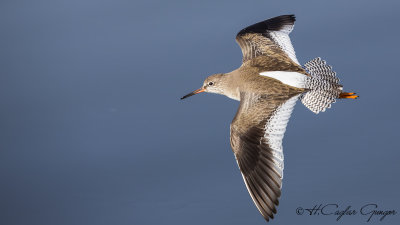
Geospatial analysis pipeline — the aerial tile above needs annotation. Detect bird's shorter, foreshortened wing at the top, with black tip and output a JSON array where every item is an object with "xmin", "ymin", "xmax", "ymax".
[{"xmin": 236, "ymin": 15, "xmax": 300, "ymax": 65}]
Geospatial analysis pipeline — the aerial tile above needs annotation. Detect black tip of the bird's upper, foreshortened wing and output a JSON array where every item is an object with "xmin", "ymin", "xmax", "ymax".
[{"xmin": 237, "ymin": 14, "xmax": 296, "ymax": 36}]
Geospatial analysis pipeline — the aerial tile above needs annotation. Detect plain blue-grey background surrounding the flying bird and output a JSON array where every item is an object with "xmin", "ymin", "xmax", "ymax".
[{"xmin": 0, "ymin": 0, "xmax": 400, "ymax": 225}]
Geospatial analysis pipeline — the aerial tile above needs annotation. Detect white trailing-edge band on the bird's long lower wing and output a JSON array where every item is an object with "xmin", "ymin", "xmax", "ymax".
[{"xmin": 264, "ymin": 95, "xmax": 300, "ymax": 178}]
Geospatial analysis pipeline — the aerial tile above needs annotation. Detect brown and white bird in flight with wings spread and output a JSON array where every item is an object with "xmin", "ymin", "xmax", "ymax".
[{"xmin": 181, "ymin": 15, "xmax": 358, "ymax": 221}]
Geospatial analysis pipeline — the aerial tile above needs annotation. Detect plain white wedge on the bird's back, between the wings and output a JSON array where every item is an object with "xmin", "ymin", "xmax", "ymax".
[{"xmin": 260, "ymin": 71, "xmax": 307, "ymax": 88}]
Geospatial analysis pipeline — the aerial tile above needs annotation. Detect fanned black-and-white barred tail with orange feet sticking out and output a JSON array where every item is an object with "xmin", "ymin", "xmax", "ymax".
[{"xmin": 301, "ymin": 57, "xmax": 358, "ymax": 113}]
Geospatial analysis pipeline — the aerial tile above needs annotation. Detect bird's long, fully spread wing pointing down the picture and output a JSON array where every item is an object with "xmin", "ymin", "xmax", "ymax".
[{"xmin": 231, "ymin": 94, "xmax": 299, "ymax": 221}]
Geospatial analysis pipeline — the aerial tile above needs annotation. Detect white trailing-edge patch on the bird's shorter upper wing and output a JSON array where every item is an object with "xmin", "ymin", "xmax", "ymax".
[{"xmin": 269, "ymin": 25, "xmax": 300, "ymax": 65}]
